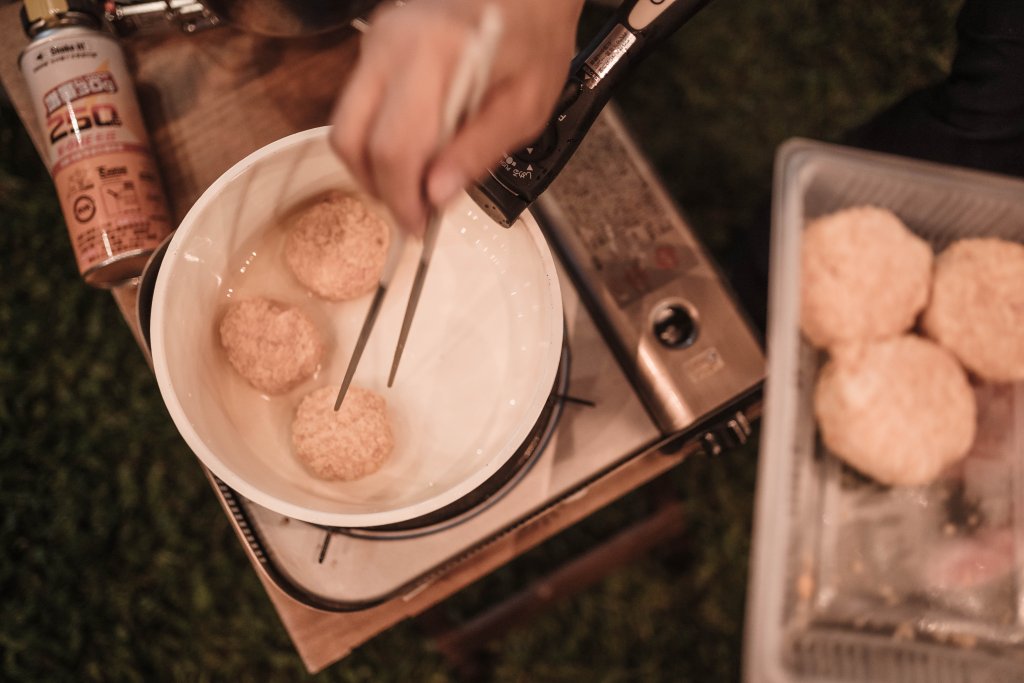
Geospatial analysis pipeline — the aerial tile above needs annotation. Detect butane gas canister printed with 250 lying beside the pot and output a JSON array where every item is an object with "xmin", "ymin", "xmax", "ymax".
[{"xmin": 19, "ymin": 0, "xmax": 171, "ymax": 287}]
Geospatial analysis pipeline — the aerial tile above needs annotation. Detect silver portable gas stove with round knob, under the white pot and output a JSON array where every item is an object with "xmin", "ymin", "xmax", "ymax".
[{"xmin": 199, "ymin": 108, "xmax": 765, "ymax": 611}]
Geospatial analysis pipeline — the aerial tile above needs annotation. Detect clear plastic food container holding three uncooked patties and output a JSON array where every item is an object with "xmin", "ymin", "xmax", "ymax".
[{"xmin": 744, "ymin": 139, "xmax": 1024, "ymax": 683}]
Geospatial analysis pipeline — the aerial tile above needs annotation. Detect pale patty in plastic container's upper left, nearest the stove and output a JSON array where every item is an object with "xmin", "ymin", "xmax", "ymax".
[{"xmin": 800, "ymin": 206, "xmax": 933, "ymax": 348}]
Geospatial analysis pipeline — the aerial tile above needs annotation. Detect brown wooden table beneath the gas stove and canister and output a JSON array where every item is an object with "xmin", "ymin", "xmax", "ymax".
[{"xmin": 0, "ymin": 3, "xmax": 737, "ymax": 672}]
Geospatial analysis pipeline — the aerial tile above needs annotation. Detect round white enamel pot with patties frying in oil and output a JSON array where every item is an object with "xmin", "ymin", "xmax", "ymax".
[{"xmin": 150, "ymin": 128, "xmax": 563, "ymax": 527}]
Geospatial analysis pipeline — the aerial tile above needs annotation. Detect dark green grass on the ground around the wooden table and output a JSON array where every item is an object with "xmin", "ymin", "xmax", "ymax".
[{"xmin": 0, "ymin": 0, "xmax": 958, "ymax": 683}]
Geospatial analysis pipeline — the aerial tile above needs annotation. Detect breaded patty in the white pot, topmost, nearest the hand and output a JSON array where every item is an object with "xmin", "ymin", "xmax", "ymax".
[{"xmin": 285, "ymin": 191, "xmax": 390, "ymax": 301}]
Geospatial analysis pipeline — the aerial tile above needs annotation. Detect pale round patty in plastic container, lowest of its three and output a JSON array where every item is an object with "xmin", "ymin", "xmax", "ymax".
[{"xmin": 814, "ymin": 335, "xmax": 976, "ymax": 485}]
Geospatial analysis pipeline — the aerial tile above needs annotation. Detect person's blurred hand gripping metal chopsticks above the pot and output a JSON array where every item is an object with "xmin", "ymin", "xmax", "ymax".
[{"xmin": 330, "ymin": 0, "xmax": 583, "ymax": 233}]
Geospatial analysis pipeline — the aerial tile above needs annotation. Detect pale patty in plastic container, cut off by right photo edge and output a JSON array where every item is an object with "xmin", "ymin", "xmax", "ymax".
[{"xmin": 922, "ymin": 238, "xmax": 1024, "ymax": 382}]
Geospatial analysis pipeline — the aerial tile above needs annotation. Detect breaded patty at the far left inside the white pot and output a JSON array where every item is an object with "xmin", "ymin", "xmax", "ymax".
[{"xmin": 220, "ymin": 298, "xmax": 324, "ymax": 394}]
